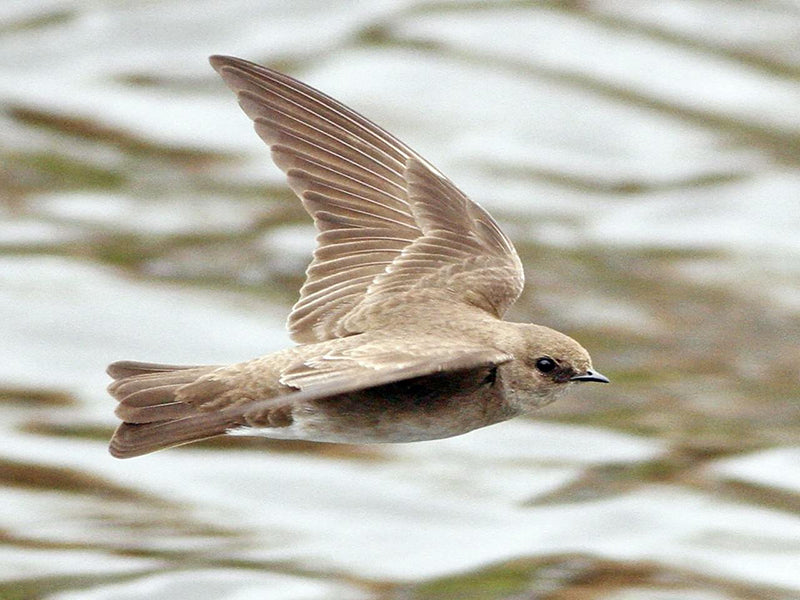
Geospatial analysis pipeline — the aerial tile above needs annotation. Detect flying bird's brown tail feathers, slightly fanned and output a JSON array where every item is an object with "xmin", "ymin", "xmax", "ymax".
[{"xmin": 107, "ymin": 361, "xmax": 234, "ymax": 458}]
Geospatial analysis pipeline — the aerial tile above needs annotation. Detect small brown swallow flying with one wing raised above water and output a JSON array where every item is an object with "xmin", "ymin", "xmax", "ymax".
[{"xmin": 107, "ymin": 55, "xmax": 609, "ymax": 458}]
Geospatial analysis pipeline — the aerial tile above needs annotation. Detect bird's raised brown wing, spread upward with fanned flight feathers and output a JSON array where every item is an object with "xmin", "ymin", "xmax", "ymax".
[{"xmin": 210, "ymin": 56, "xmax": 523, "ymax": 342}]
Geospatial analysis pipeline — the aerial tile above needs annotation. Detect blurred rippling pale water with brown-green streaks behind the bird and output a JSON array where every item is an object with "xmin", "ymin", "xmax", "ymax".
[{"xmin": 0, "ymin": 0, "xmax": 800, "ymax": 600}]
